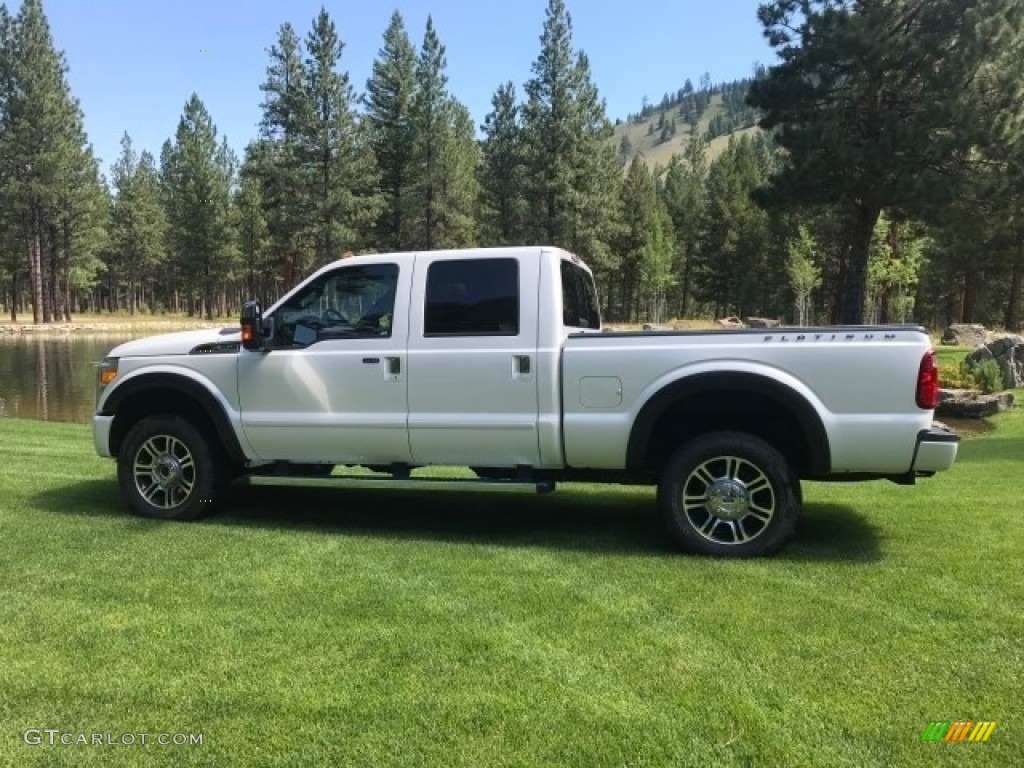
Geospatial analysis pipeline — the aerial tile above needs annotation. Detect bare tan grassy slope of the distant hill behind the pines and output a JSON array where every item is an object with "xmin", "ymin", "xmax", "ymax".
[{"xmin": 613, "ymin": 81, "xmax": 760, "ymax": 176}]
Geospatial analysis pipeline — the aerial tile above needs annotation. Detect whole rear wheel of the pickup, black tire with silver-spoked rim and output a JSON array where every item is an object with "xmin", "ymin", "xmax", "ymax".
[{"xmin": 657, "ymin": 432, "xmax": 801, "ymax": 557}]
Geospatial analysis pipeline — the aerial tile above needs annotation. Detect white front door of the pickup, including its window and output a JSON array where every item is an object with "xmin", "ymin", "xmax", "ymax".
[{"xmin": 239, "ymin": 260, "xmax": 412, "ymax": 464}]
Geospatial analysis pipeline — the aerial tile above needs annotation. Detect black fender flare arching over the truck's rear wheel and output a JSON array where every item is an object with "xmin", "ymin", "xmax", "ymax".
[{"xmin": 626, "ymin": 371, "xmax": 831, "ymax": 476}]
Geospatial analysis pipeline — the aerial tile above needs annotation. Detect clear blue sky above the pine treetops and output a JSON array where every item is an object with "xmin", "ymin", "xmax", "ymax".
[{"xmin": 16, "ymin": 0, "xmax": 774, "ymax": 180}]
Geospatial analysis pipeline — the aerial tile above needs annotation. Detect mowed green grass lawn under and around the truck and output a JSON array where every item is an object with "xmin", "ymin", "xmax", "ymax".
[{"xmin": 0, "ymin": 405, "xmax": 1024, "ymax": 768}]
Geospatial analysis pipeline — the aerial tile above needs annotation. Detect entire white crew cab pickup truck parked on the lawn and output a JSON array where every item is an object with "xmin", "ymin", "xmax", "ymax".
[{"xmin": 93, "ymin": 246, "xmax": 958, "ymax": 557}]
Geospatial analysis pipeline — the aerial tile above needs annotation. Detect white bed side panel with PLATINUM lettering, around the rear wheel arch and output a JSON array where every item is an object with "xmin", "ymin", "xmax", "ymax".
[{"xmin": 562, "ymin": 327, "xmax": 933, "ymax": 473}]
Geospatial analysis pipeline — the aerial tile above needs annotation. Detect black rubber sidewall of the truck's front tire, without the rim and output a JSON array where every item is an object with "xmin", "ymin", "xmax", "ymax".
[{"xmin": 118, "ymin": 416, "xmax": 218, "ymax": 520}]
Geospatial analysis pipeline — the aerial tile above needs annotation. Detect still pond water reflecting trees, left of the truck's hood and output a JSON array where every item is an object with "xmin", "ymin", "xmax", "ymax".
[{"xmin": 0, "ymin": 334, "xmax": 136, "ymax": 423}]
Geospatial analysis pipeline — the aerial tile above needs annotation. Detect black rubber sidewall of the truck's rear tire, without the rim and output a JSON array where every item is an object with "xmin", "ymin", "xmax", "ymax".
[{"xmin": 658, "ymin": 432, "xmax": 801, "ymax": 557}]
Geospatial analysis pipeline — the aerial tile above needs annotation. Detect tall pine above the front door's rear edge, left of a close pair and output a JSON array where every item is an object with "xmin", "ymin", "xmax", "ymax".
[{"xmin": 365, "ymin": 11, "xmax": 416, "ymax": 251}]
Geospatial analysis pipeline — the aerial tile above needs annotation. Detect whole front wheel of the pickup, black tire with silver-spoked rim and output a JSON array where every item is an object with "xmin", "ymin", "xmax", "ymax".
[{"xmin": 118, "ymin": 416, "xmax": 230, "ymax": 520}]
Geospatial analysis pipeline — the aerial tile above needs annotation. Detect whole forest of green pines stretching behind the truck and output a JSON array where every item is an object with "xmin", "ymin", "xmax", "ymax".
[{"xmin": 0, "ymin": 0, "xmax": 1024, "ymax": 330}]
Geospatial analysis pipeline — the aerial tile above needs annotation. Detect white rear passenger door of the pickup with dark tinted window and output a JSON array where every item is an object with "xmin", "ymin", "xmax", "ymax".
[{"xmin": 409, "ymin": 256, "xmax": 541, "ymax": 466}]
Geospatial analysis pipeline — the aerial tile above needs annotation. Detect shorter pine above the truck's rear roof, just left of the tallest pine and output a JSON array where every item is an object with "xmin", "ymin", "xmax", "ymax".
[{"xmin": 480, "ymin": 82, "xmax": 526, "ymax": 245}]
